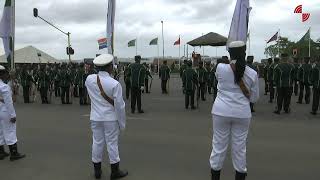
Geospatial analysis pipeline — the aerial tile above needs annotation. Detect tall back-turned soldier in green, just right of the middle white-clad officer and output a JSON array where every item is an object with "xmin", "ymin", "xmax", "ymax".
[{"xmin": 128, "ymin": 56, "xmax": 145, "ymax": 114}]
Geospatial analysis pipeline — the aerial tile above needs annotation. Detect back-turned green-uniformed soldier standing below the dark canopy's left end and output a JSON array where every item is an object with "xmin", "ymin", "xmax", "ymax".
[{"xmin": 182, "ymin": 61, "xmax": 198, "ymax": 109}]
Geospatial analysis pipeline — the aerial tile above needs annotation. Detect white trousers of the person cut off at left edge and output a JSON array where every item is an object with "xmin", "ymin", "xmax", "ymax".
[{"xmin": 0, "ymin": 111, "xmax": 18, "ymax": 146}]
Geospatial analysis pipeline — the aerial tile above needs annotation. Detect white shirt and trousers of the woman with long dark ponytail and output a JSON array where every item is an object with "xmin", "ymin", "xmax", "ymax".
[{"xmin": 210, "ymin": 64, "xmax": 259, "ymax": 173}]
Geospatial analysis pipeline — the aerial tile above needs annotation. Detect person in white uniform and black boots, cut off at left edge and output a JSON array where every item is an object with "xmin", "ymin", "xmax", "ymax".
[{"xmin": 0, "ymin": 65, "xmax": 26, "ymax": 161}]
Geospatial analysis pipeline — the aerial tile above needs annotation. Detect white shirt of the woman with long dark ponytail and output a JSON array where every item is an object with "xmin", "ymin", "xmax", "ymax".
[{"xmin": 211, "ymin": 63, "xmax": 259, "ymax": 118}]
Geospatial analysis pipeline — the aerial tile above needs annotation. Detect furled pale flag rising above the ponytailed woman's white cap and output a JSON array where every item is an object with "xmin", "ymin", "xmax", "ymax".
[{"xmin": 227, "ymin": 0, "xmax": 252, "ymax": 48}]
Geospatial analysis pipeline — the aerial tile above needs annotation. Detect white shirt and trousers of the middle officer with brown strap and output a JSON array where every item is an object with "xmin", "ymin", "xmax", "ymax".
[{"xmin": 85, "ymin": 72, "xmax": 126, "ymax": 164}]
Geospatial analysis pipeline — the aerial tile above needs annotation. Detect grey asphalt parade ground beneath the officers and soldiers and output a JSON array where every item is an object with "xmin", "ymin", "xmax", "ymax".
[{"xmin": 0, "ymin": 76, "xmax": 320, "ymax": 180}]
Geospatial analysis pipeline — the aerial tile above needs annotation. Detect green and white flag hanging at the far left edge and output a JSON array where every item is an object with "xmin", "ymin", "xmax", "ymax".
[{"xmin": 0, "ymin": 0, "xmax": 14, "ymax": 66}]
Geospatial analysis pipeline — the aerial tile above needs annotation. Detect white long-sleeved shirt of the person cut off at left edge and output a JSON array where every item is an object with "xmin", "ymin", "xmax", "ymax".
[{"xmin": 0, "ymin": 80, "xmax": 16, "ymax": 118}]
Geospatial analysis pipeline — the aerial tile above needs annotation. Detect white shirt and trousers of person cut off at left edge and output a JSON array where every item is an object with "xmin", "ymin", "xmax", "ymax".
[{"xmin": 0, "ymin": 80, "xmax": 17, "ymax": 146}]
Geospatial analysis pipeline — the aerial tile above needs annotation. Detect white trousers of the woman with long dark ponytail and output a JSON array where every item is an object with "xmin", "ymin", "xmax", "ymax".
[{"xmin": 210, "ymin": 115, "xmax": 250, "ymax": 173}]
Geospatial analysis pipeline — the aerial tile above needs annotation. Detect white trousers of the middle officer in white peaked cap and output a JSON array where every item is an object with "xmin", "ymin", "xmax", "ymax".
[{"xmin": 91, "ymin": 121, "xmax": 120, "ymax": 164}]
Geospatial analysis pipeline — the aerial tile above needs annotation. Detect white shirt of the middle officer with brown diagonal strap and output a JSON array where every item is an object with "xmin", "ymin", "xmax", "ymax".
[{"xmin": 85, "ymin": 72, "xmax": 126, "ymax": 129}]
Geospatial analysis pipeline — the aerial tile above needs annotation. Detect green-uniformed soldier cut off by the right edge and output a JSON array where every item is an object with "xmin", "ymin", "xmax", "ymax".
[{"xmin": 310, "ymin": 57, "xmax": 320, "ymax": 115}]
